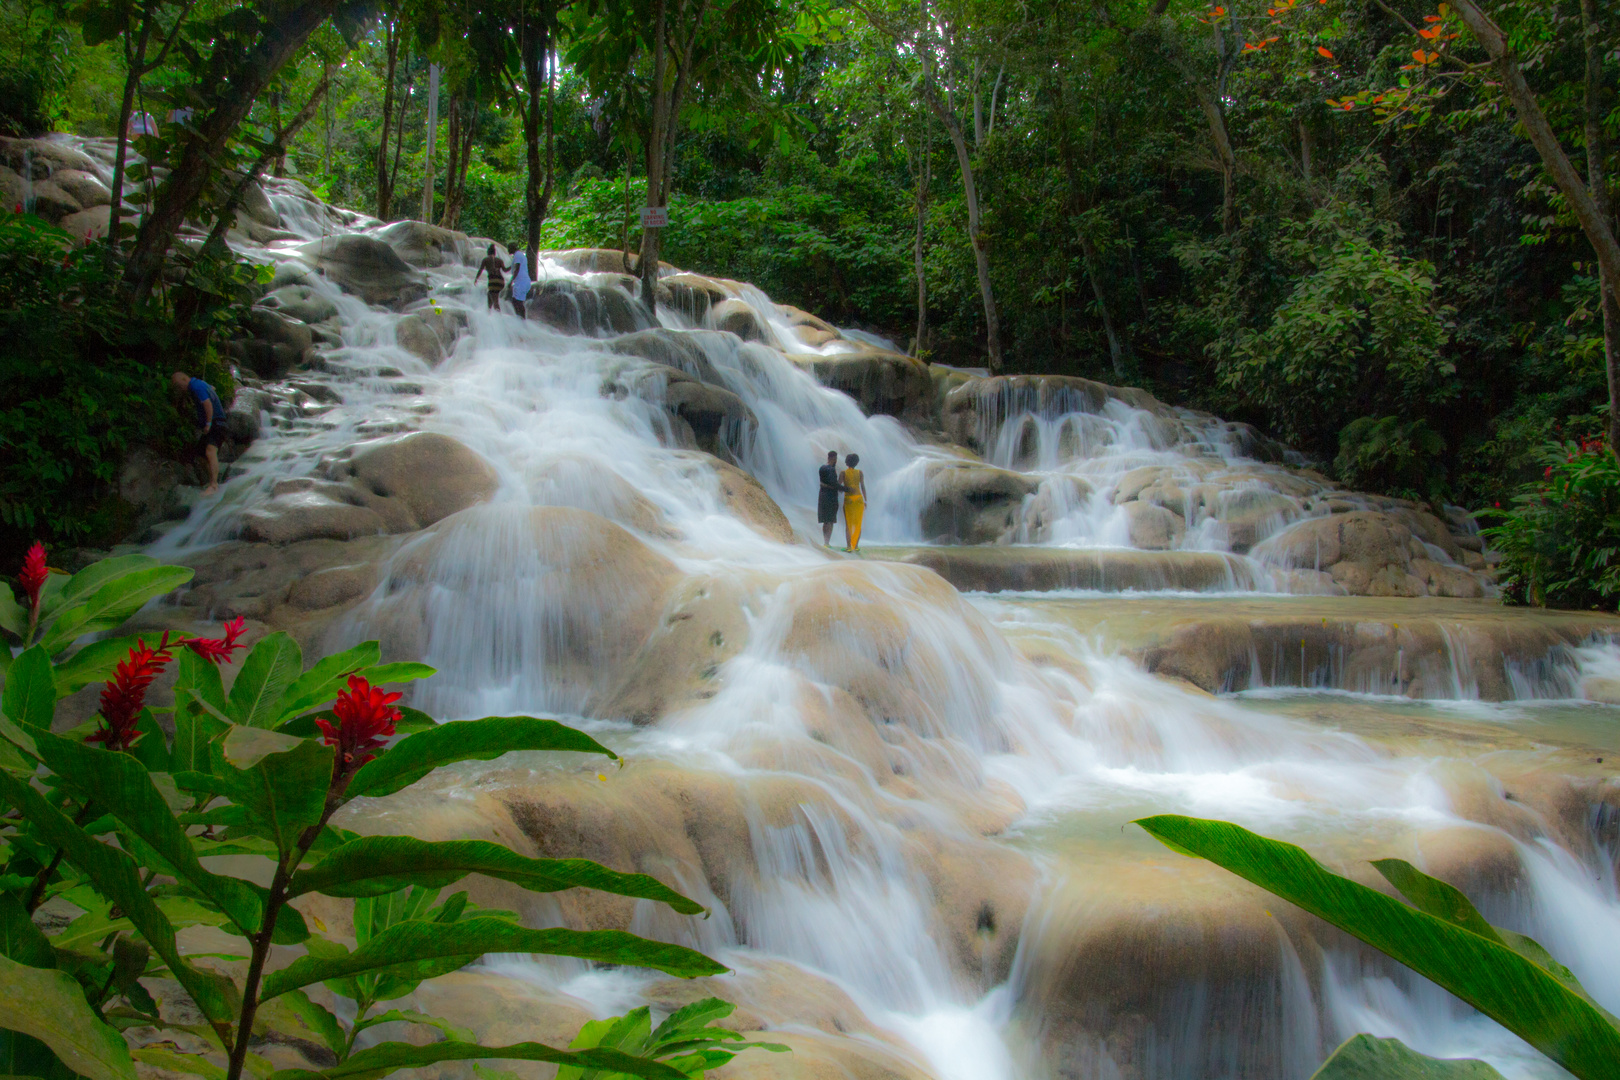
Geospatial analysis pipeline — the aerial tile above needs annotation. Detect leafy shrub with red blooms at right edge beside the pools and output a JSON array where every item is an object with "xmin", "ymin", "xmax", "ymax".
[{"xmin": 1484, "ymin": 439, "xmax": 1620, "ymax": 610}]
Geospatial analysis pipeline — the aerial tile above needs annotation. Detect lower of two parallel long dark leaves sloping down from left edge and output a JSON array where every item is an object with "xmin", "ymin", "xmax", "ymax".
[{"xmin": 0, "ymin": 772, "xmax": 237, "ymax": 1023}]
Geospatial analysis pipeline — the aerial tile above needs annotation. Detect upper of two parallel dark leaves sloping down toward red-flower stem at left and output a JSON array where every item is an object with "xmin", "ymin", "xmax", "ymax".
[{"xmin": 34, "ymin": 732, "xmax": 264, "ymax": 938}]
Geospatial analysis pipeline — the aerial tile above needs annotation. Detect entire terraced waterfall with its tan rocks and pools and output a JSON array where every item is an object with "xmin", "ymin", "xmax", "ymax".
[{"xmin": 117, "ymin": 156, "xmax": 1620, "ymax": 1080}]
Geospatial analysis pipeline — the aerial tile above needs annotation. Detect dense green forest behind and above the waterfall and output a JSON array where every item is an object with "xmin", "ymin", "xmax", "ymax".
[{"xmin": 0, "ymin": 0, "xmax": 1620, "ymax": 573}]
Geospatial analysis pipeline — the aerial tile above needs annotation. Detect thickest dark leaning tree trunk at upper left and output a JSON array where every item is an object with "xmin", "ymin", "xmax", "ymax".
[{"xmin": 125, "ymin": 0, "xmax": 340, "ymax": 301}]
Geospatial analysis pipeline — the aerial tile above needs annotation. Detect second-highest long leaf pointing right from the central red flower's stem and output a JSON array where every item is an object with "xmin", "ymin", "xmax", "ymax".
[{"xmin": 288, "ymin": 836, "xmax": 703, "ymax": 915}]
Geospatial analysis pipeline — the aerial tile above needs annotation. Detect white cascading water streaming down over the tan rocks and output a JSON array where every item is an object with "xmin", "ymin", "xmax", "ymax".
[{"xmin": 145, "ymin": 196, "xmax": 1620, "ymax": 1080}]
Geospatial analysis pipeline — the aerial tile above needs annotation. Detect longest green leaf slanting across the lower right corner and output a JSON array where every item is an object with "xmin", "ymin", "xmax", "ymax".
[{"xmin": 1137, "ymin": 814, "xmax": 1620, "ymax": 1080}]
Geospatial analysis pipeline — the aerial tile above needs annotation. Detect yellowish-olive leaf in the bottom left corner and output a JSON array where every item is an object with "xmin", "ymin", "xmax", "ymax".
[{"xmin": 0, "ymin": 957, "xmax": 134, "ymax": 1080}]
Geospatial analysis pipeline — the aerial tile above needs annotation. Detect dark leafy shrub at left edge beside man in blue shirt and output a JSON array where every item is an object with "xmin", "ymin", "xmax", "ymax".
[{"xmin": 0, "ymin": 212, "xmax": 240, "ymax": 552}]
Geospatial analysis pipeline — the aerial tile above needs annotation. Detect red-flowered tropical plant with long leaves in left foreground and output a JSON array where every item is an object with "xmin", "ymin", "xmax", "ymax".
[{"xmin": 0, "ymin": 544, "xmax": 764, "ymax": 1080}]
